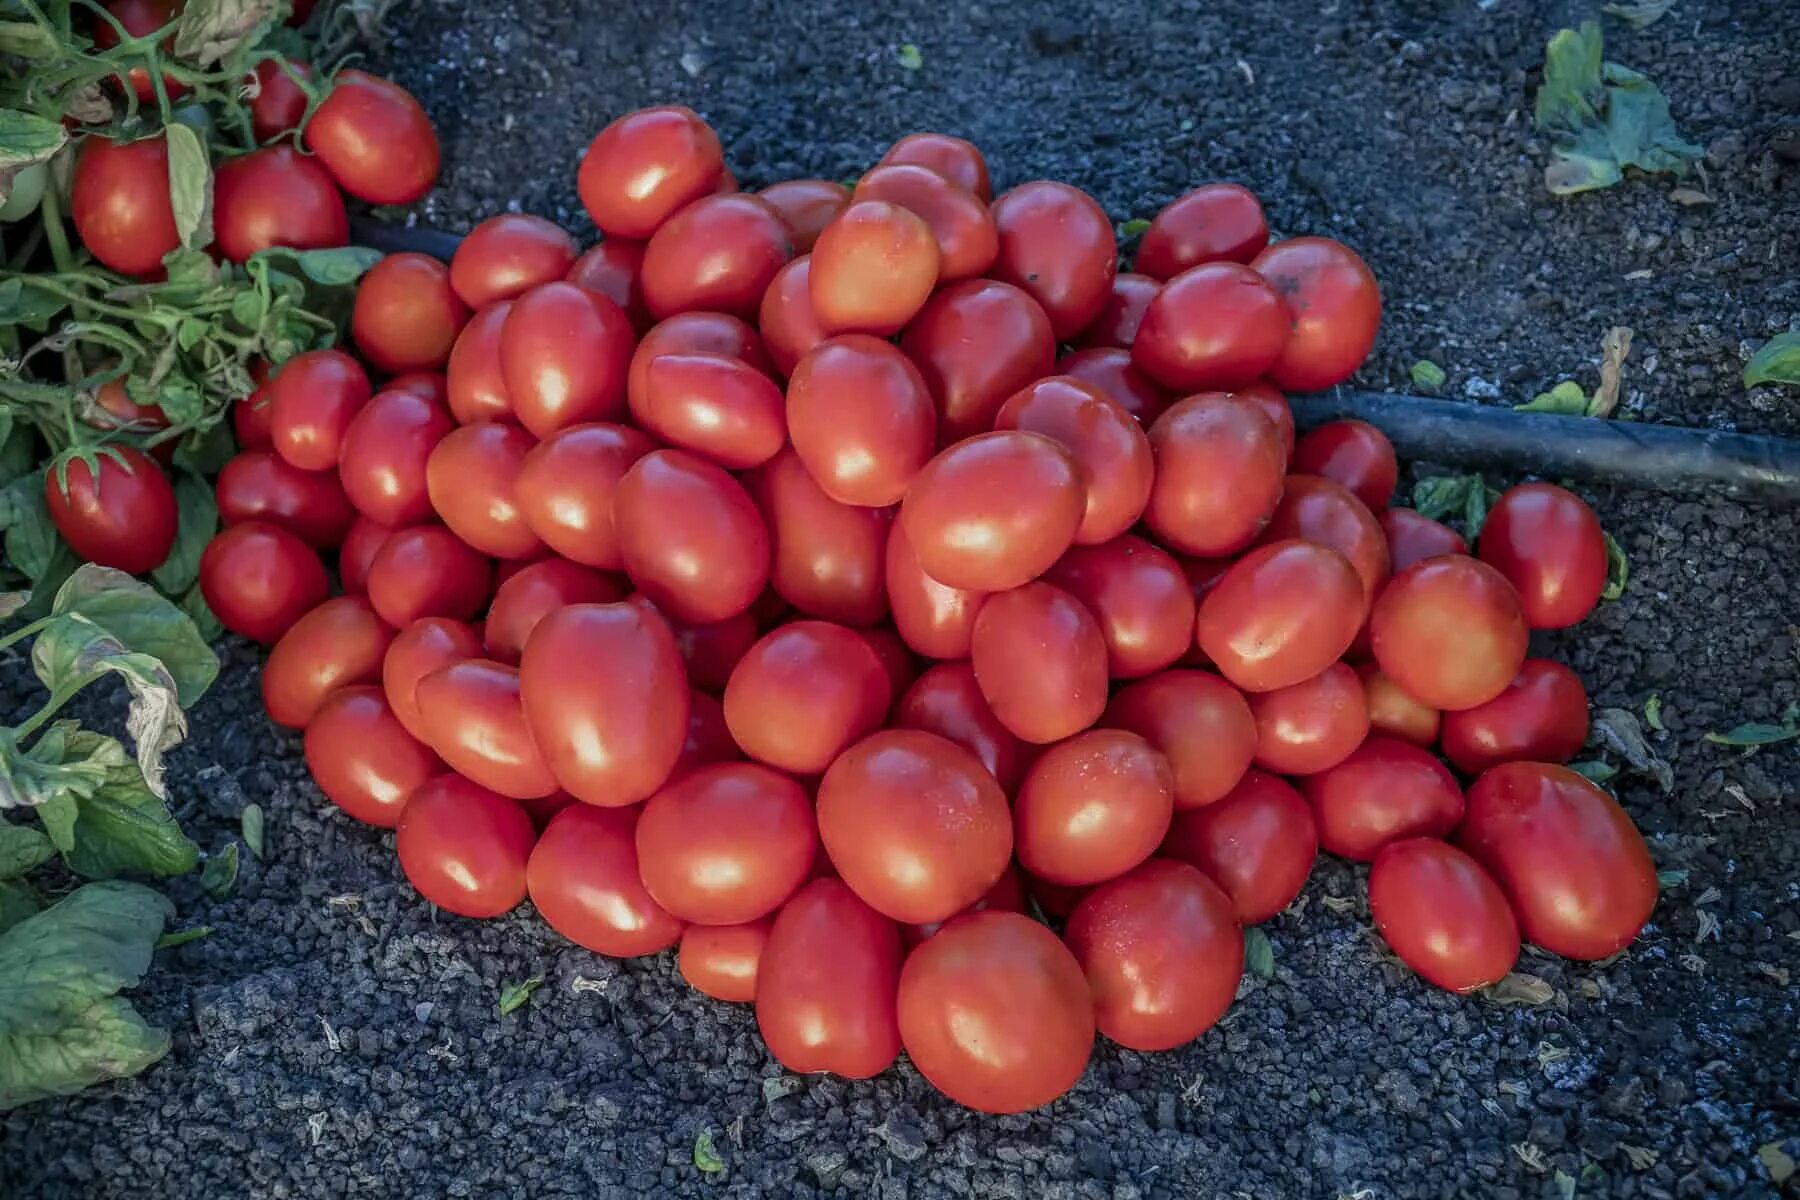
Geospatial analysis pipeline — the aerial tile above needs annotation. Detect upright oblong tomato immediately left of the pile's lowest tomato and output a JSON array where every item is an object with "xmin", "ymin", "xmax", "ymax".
[{"xmin": 756, "ymin": 878, "xmax": 900, "ymax": 1079}]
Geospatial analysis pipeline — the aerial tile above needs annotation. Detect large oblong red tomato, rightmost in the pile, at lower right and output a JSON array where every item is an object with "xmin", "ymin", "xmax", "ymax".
[{"xmin": 1456, "ymin": 763, "xmax": 1656, "ymax": 961}]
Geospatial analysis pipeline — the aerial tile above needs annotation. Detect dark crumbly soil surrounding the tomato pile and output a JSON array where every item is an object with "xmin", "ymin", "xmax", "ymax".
[{"xmin": 0, "ymin": 0, "xmax": 1800, "ymax": 1200}]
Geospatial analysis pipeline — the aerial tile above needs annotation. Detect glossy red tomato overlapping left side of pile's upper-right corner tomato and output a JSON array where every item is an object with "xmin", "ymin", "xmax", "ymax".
[{"xmin": 1130, "ymin": 263, "xmax": 1289, "ymax": 392}]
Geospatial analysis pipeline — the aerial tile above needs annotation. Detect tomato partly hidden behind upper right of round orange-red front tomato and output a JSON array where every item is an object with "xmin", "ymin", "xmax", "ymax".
[{"xmin": 1103, "ymin": 671, "xmax": 1256, "ymax": 811}]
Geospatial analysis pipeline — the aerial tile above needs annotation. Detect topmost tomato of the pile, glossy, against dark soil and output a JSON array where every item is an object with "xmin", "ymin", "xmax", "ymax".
[{"xmin": 576, "ymin": 104, "xmax": 725, "ymax": 237}]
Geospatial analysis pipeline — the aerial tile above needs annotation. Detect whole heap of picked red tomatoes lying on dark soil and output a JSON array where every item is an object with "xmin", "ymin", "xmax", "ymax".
[{"xmin": 202, "ymin": 108, "xmax": 1656, "ymax": 1112}]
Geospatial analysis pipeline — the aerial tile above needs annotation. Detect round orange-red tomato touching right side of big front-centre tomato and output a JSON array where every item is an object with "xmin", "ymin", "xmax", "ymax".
[{"xmin": 1013, "ymin": 729, "xmax": 1175, "ymax": 885}]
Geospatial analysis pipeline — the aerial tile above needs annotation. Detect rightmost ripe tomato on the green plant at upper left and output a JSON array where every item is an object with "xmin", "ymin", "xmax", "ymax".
[{"xmin": 302, "ymin": 70, "xmax": 439, "ymax": 203}]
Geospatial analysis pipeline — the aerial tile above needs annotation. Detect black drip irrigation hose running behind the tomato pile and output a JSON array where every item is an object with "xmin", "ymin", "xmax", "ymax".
[{"xmin": 351, "ymin": 218, "xmax": 1800, "ymax": 507}]
